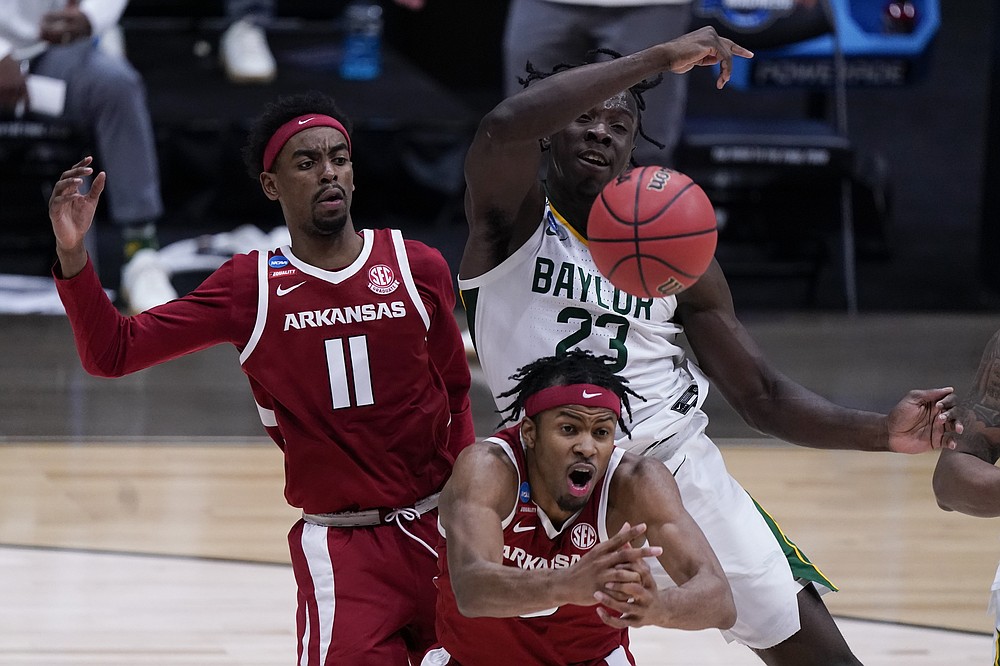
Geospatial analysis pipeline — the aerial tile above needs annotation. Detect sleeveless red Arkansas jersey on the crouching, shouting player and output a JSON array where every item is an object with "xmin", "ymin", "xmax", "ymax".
[{"xmin": 437, "ymin": 426, "xmax": 632, "ymax": 666}]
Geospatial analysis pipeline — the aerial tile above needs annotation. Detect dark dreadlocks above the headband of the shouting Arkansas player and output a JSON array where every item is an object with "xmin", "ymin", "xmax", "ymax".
[{"xmin": 499, "ymin": 349, "xmax": 645, "ymax": 435}]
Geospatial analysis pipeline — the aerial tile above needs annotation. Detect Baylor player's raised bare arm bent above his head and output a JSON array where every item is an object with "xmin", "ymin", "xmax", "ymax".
[{"xmin": 461, "ymin": 27, "xmax": 753, "ymax": 277}]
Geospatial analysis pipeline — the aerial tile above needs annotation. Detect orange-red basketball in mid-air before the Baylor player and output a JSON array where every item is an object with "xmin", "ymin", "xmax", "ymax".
[{"xmin": 587, "ymin": 166, "xmax": 718, "ymax": 298}]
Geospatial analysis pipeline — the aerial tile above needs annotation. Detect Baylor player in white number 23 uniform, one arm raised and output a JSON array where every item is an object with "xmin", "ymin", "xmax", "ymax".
[{"xmin": 459, "ymin": 28, "xmax": 951, "ymax": 666}]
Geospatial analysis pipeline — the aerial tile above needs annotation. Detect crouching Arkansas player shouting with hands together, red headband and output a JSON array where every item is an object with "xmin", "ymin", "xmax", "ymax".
[{"xmin": 424, "ymin": 351, "xmax": 736, "ymax": 666}]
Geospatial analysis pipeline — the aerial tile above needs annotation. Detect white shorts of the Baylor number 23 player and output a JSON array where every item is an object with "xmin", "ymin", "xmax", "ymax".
[{"xmin": 649, "ymin": 411, "xmax": 802, "ymax": 649}]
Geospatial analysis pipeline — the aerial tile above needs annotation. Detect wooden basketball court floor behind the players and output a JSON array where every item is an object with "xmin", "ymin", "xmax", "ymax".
[{"xmin": 0, "ymin": 317, "xmax": 1000, "ymax": 666}]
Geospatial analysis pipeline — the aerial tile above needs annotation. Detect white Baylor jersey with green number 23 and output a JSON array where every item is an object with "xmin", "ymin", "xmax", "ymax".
[{"xmin": 458, "ymin": 203, "xmax": 708, "ymax": 459}]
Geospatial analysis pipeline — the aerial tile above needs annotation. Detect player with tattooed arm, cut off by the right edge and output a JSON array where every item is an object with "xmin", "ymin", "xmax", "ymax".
[{"xmin": 934, "ymin": 331, "xmax": 1000, "ymax": 664}]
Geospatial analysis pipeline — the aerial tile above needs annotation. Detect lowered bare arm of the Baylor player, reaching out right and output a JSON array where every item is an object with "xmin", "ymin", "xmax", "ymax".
[{"xmin": 677, "ymin": 261, "xmax": 952, "ymax": 453}]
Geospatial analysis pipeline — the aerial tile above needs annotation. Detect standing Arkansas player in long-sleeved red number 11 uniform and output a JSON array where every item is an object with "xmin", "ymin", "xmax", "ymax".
[{"xmin": 49, "ymin": 94, "xmax": 475, "ymax": 666}]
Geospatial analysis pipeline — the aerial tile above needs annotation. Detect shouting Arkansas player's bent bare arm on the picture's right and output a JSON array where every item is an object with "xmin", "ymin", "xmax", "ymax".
[{"xmin": 597, "ymin": 455, "xmax": 736, "ymax": 630}]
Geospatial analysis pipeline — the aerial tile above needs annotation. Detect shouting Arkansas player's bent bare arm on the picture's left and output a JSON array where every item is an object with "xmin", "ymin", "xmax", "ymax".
[{"xmin": 439, "ymin": 442, "xmax": 659, "ymax": 617}]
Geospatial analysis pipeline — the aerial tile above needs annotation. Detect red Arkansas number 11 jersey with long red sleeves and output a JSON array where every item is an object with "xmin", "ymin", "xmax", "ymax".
[{"xmin": 57, "ymin": 229, "xmax": 475, "ymax": 513}]
